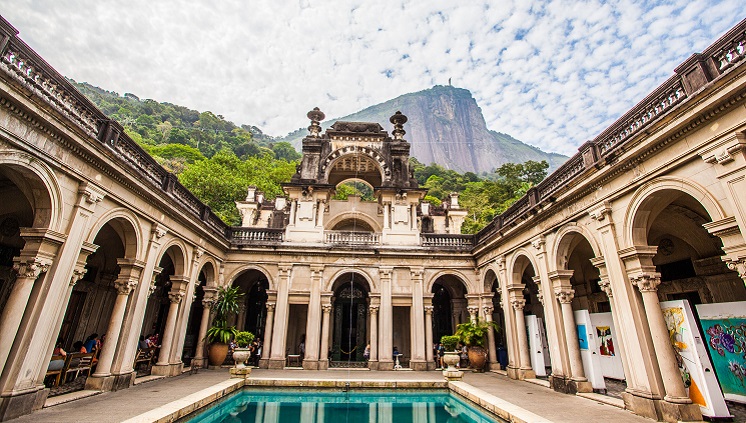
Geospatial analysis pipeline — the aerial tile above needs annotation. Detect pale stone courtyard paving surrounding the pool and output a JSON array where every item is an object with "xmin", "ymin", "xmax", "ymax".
[{"xmin": 7, "ymin": 369, "xmax": 743, "ymax": 423}]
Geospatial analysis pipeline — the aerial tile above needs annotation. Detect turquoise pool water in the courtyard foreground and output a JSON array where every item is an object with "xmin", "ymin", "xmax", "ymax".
[{"xmin": 182, "ymin": 389, "xmax": 502, "ymax": 423}]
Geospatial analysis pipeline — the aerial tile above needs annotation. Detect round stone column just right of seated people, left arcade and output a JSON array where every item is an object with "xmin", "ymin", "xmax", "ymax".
[{"xmin": 86, "ymin": 278, "xmax": 140, "ymax": 391}]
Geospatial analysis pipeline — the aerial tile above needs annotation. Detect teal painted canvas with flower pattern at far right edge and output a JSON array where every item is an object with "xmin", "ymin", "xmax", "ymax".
[{"xmin": 702, "ymin": 318, "xmax": 746, "ymax": 396}]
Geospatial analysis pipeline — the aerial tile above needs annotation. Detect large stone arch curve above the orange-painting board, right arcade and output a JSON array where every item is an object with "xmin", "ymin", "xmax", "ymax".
[{"xmin": 624, "ymin": 177, "xmax": 725, "ymax": 247}]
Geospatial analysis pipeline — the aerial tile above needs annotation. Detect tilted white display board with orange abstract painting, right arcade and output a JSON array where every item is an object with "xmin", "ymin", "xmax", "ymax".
[{"xmin": 661, "ymin": 300, "xmax": 730, "ymax": 417}]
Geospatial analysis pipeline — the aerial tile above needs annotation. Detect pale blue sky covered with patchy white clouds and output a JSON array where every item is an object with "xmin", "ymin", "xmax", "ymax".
[{"xmin": 0, "ymin": 0, "xmax": 743, "ymax": 154}]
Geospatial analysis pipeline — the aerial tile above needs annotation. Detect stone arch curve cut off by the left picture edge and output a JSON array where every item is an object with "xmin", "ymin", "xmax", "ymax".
[{"xmin": 0, "ymin": 150, "xmax": 64, "ymax": 232}]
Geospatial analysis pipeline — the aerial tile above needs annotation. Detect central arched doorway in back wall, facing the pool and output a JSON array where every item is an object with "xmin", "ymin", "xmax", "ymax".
[{"xmin": 332, "ymin": 272, "xmax": 368, "ymax": 363}]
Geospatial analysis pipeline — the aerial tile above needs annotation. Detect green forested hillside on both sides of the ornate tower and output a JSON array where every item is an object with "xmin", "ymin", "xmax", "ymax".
[{"xmin": 72, "ymin": 83, "xmax": 549, "ymax": 233}]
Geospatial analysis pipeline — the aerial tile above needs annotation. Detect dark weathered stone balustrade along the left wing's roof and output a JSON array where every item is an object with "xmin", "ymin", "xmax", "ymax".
[{"xmin": 0, "ymin": 17, "xmax": 228, "ymax": 237}]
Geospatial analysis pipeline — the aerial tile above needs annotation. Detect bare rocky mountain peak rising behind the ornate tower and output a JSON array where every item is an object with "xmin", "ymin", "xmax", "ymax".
[{"xmin": 278, "ymin": 85, "xmax": 567, "ymax": 173}]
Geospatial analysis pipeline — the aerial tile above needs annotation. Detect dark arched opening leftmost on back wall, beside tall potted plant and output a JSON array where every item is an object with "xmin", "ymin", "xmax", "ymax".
[{"xmin": 233, "ymin": 269, "xmax": 269, "ymax": 338}]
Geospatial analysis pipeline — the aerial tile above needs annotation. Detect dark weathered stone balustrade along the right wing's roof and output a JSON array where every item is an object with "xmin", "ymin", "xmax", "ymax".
[{"xmin": 474, "ymin": 19, "xmax": 746, "ymax": 245}]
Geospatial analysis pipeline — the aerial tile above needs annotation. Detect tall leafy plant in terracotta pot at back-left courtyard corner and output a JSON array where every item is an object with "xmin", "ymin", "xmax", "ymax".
[{"xmin": 207, "ymin": 286, "xmax": 244, "ymax": 366}]
